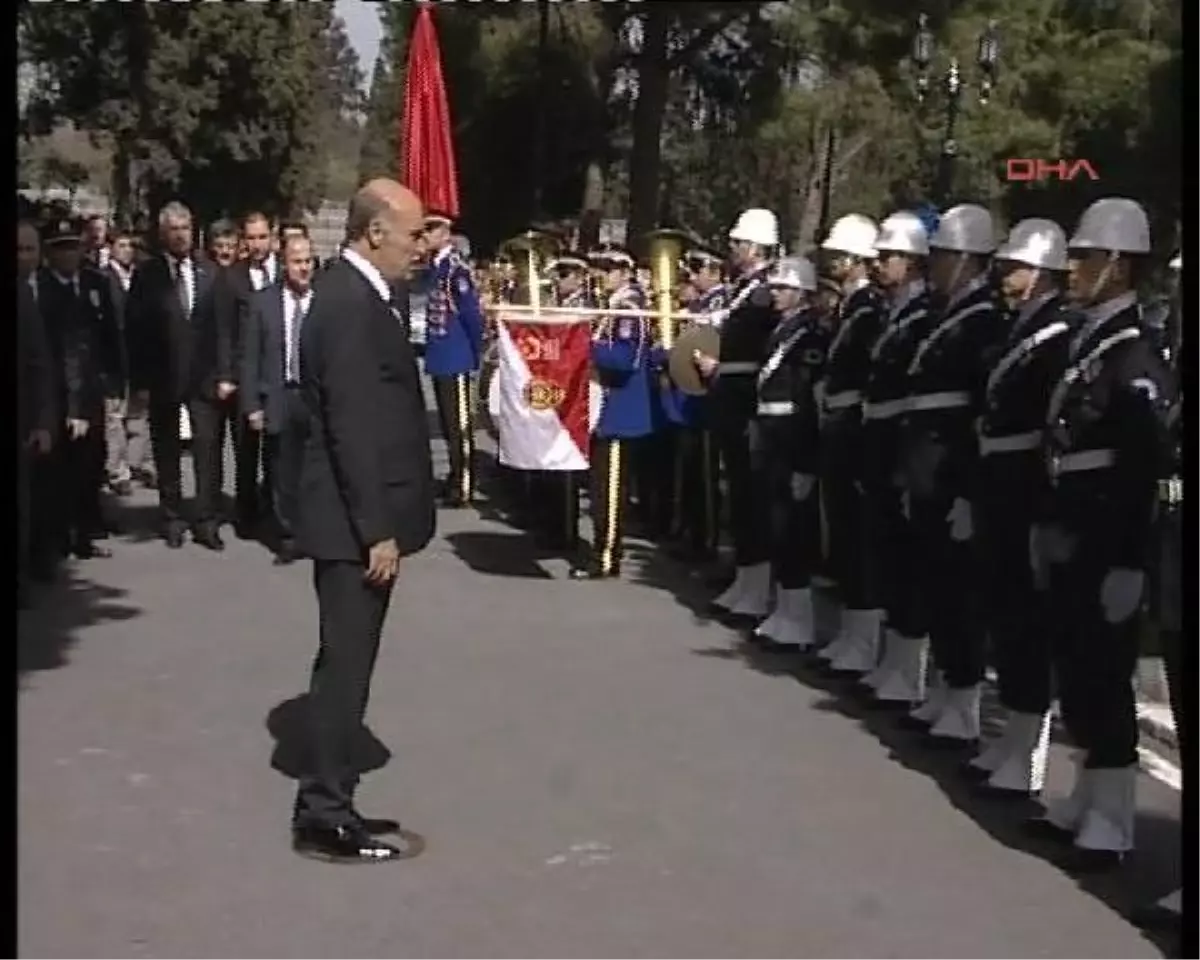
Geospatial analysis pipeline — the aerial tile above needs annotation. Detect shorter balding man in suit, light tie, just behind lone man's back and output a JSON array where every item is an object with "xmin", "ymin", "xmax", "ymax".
[{"xmin": 238, "ymin": 236, "xmax": 313, "ymax": 564}]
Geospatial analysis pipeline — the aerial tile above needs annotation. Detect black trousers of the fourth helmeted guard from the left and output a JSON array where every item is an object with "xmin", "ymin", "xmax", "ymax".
[{"xmin": 863, "ymin": 420, "xmax": 929, "ymax": 637}]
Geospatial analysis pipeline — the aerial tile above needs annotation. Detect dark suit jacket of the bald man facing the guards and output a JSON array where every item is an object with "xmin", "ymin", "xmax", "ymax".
[{"xmin": 296, "ymin": 263, "xmax": 437, "ymax": 560}]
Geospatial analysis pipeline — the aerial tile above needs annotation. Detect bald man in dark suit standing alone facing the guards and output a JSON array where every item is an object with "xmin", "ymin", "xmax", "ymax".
[{"xmin": 293, "ymin": 180, "xmax": 437, "ymax": 863}]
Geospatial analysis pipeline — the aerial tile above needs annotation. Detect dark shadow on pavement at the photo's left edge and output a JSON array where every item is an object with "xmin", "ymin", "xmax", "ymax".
[{"xmin": 17, "ymin": 573, "xmax": 142, "ymax": 679}]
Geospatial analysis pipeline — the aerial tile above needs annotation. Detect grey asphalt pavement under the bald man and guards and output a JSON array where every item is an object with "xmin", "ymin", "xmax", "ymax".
[{"xmin": 17, "ymin": 424, "xmax": 1180, "ymax": 960}]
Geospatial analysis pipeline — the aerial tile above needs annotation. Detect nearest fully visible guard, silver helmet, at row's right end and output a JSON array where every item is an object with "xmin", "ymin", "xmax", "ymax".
[{"xmin": 1031, "ymin": 198, "xmax": 1174, "ymax": 871}]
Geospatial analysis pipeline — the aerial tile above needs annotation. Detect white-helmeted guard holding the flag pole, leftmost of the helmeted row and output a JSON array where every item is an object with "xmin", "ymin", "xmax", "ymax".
[{"xmin": 696, "ymin": 209, "xmax": 779, "ymax": 619}]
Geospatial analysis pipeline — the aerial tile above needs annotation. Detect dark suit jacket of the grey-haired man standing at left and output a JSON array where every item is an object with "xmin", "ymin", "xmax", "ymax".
[{"xmin": 125, "ymin": 254, "xmax": 225, "ymax": 402}]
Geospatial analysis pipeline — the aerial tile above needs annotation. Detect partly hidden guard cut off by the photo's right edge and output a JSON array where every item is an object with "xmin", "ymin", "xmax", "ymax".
[{"xmin": 1132, "ymin": 247, "xmax": 1190, "ymax": 930}]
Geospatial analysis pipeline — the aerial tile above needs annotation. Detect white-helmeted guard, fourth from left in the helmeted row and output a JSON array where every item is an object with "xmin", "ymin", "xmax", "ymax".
[{"xmin": 863, "ymin": 211, "xmax": 934, "ymax": 704}]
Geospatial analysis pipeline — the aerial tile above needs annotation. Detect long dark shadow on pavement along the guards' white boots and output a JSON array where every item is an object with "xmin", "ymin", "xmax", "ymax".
[{"xmin": 692, "ymin": 635, "xmax": 1182, "ymax": 958}]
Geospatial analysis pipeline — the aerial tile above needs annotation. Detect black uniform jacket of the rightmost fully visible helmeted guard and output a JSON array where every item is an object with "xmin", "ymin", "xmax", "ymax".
[{"xmin": 1045, "ymin": 294, "xmax": 1176, "ymax": 570}]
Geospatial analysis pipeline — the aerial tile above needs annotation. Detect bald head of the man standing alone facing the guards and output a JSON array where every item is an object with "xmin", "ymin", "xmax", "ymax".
[{"xmin": 346, "ymin": 178, "xmax": 424, "ymax": 280}]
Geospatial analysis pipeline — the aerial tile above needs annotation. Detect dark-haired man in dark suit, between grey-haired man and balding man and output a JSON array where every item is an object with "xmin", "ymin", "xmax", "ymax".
[{"xmin": 216, "ymin": 211, "xmax": 280, "ymax": 539}]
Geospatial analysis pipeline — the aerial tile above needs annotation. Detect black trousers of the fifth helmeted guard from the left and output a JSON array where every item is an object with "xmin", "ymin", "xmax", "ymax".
[{"xmin": 908, "ymin": 491, "xmax": 986, "ymax": 689}]
